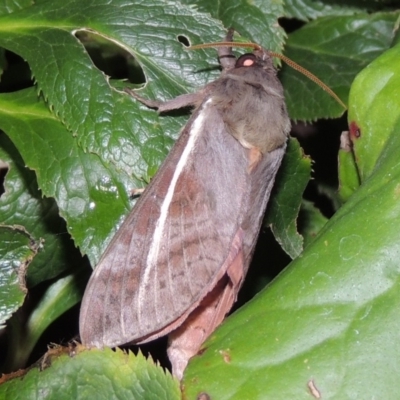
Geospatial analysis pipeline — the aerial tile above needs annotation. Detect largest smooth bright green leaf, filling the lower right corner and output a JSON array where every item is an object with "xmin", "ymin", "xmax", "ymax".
[{"xmin": 184, "ymin": 36, "xmax": 400, "ymax": 400}]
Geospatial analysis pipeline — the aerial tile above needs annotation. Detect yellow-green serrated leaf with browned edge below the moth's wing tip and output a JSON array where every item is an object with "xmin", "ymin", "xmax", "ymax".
[{"xmin": 0, "ymin": 345, "xmax": 181, "ymax": 400}]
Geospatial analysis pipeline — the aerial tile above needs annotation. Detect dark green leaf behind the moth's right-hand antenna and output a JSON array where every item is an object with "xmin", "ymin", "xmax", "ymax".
[{"xmin": 281, "ymin": 12, "xmax": 399, "ymax": 121}]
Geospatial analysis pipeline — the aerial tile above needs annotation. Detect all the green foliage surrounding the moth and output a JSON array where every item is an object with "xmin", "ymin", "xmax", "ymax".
[{"xmin": 0, "ymin": 0, "xmax": 400, "ymax": 399}]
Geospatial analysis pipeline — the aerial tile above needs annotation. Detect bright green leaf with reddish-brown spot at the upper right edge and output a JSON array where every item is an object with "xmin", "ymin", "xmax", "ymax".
[{"xmin": 348, "ymin": 43, "xmax": 400, "ymax": 181}]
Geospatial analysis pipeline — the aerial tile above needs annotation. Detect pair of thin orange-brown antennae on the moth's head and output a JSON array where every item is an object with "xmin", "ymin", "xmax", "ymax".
[{"xmin": 187, "ymin": 42, "xmax": 347, "ymax": 110}]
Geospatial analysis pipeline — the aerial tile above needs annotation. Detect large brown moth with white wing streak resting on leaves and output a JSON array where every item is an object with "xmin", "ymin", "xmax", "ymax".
[{"xmin": 80, "ymin": 32, "xmax": 290, "ymax": 378}]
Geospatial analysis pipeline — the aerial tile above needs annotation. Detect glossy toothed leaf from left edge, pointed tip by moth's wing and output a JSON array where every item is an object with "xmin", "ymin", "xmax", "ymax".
[{"xmin": 0, "ymin": 89, "xmax": 129, "ymax": 268}]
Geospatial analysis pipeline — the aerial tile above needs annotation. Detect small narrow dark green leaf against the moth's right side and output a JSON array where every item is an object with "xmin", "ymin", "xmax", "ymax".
[{"xmin": 266, "ymin": 139, "xmax": 311, "ymax": 258}]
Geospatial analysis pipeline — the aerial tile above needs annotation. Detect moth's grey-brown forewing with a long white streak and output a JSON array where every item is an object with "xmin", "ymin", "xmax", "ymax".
[{"xmin": 80, "ymin": 97, "xmax": 250, "ymax": 347}]
